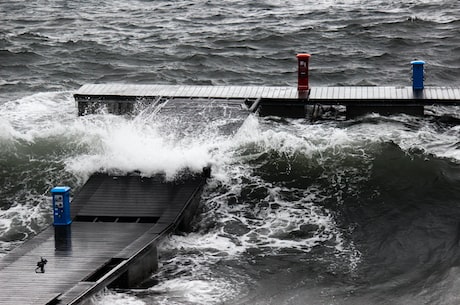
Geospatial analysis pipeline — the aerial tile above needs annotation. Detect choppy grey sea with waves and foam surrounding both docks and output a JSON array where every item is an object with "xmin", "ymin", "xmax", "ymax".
[{"xmin": 0, "ymin": 0, "xmax": 460, "ymax": 304}]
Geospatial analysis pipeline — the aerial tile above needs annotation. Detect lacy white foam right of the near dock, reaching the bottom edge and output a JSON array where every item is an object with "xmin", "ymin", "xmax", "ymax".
[{"xmin": 109, "ymin": 116, "xmax": 360, "ymax": 304}]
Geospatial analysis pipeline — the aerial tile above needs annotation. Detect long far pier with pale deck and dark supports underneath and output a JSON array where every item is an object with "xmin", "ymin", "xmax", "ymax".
[{"xmin": 74, "ymin": 84, "xmax": 460, "ymax": 117}]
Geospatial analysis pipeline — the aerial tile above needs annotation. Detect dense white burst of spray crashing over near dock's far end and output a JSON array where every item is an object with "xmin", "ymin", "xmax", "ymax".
[{"xmin": 66, "ymin": 112, "xmax": 213, "ymax": 177}]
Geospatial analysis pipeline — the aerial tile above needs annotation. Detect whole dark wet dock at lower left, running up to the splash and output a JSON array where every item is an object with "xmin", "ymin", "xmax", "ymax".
[{"xmin": 0, "ymin": 174, "xmax": 206, "ymax": 305}]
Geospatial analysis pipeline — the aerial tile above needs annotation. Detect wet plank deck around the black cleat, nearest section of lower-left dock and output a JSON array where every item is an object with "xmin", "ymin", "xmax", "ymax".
[{"xmin": 0, "ymin": 222, "xmax": 153, "ymax": 305}]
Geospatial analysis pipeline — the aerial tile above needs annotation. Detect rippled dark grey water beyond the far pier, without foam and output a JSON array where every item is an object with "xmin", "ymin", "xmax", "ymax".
[{"xmin": 0, "ymin": 0, "xmax": 460, "ymax": 100}]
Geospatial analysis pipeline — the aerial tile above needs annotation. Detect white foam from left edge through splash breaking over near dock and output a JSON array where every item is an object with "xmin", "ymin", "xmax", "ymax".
[{"xmin": 0, "ymin": 92, "xmax": 230, "ymax": 178}]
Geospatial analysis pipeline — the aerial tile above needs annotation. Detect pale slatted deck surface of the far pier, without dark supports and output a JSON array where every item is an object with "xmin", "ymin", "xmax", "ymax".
[{"xmin": 74, "ymin": 84, "xmax": 460, "ymax": 105}]
